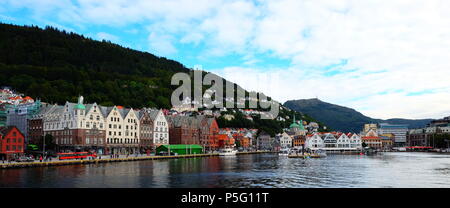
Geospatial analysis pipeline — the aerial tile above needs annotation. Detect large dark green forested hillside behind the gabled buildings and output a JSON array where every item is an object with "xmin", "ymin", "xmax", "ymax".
[{"xmin": 0, "ymin": 24, "xmax": 326, "ymax": 136}]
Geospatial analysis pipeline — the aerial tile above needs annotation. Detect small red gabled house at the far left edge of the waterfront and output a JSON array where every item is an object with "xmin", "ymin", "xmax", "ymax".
[{"xmin": 0, "ymin": 126, "xmax": 25, "ymax": 160}]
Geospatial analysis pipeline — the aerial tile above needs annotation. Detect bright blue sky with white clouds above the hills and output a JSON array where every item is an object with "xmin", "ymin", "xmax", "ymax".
[{"xmin": 0, "ymin": 0, "xmax": 450, "ymax": 119}]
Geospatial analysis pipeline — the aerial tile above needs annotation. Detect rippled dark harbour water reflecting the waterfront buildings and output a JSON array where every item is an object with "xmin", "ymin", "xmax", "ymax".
[{"xmin": 0, "ymin": 152, "xmax": 450, "ymax": 188}]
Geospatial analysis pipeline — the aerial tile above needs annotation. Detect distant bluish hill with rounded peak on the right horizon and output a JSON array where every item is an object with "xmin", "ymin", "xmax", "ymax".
[{"xmin": 284, "ymin": 99, "xmax": 432, "ymax": 132}]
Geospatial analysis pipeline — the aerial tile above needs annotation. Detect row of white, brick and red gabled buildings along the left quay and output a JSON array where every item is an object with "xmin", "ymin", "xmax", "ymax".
[{"xmin": 0, "ymin": 90, "xmax": 268, "ymax": 158}]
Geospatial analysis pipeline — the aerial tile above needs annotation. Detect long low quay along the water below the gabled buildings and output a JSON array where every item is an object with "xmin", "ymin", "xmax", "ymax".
[{"xmin": 0, "ymin": 151, "xmax": 274, "ymax": 169}]
